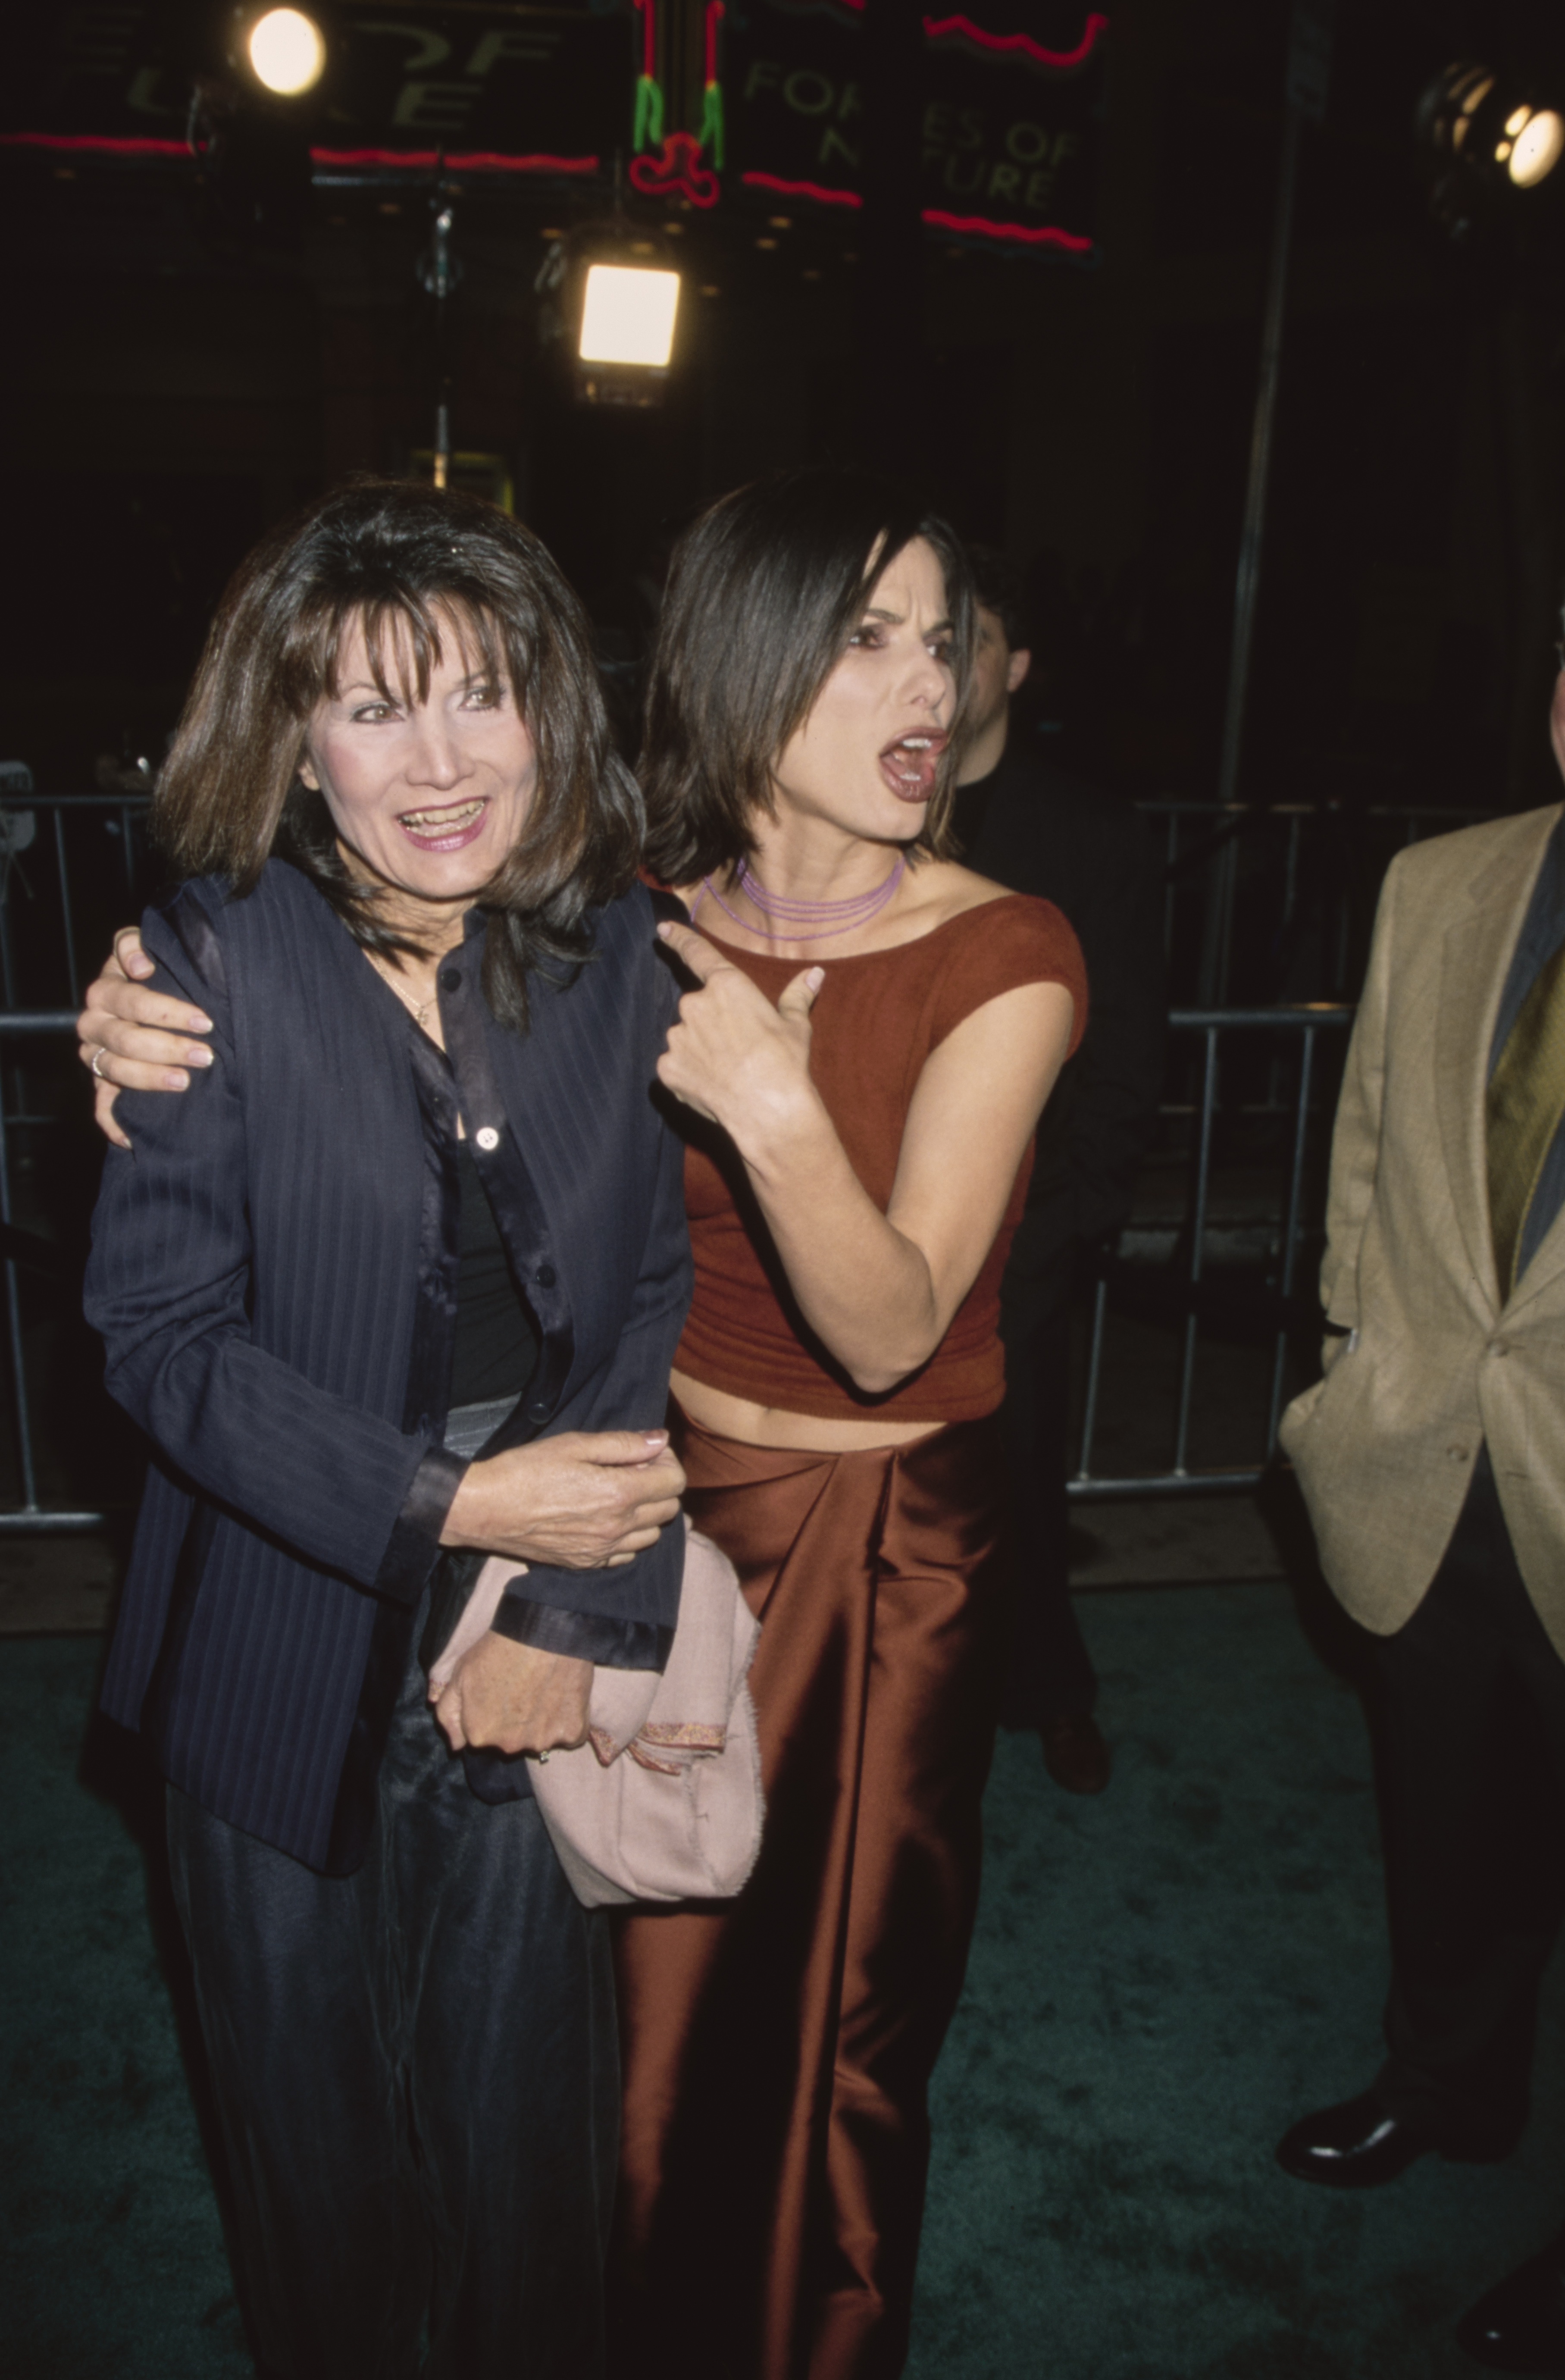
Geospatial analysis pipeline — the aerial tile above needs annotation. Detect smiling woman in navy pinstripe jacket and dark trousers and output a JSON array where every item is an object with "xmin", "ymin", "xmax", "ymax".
[{"xmin": 88, "ymin": 485, "xmax": 690, "ymax": 2380}]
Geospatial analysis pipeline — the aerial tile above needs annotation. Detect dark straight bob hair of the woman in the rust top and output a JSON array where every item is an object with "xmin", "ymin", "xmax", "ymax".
[{"xmin": 640, "ymin": 467, "xmax": 975, "ymax": 885}]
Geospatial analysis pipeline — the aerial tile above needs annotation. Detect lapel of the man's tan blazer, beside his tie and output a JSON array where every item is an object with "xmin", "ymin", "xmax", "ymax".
[{"xmin": 1434, "ymin": 809, "xmax": 1565, "ymax": 1314}]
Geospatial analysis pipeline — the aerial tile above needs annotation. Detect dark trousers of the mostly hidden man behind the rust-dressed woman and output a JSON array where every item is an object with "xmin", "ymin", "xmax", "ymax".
[{"xmin": 999, "ymin": 1292, "xmax": 1099, "ymax": 1728}]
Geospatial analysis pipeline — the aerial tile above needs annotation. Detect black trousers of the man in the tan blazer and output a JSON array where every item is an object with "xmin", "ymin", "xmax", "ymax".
[{"xmin": 1377, "ymin": 1450, "xmax": 1565, "ymax": 2154}]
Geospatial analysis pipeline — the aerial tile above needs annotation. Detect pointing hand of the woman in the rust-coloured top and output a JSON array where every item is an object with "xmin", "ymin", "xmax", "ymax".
[{"xmin": 657, "ymin": 924, "xmax": 825, "ymax": 1159}]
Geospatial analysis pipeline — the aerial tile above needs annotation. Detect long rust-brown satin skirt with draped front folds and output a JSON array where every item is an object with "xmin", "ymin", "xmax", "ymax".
[{"xmin": 611, "ymin": 1419, "xmax": 999, "ymax": 2380}]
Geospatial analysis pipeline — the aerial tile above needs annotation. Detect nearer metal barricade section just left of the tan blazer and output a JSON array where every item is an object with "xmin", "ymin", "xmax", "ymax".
[{"xmin": 1068, "ymin": 1004, "xmax": 1353, "ymax": 1504}]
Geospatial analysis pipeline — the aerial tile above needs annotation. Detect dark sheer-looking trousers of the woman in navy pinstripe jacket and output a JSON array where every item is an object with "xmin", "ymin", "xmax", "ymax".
[{"xmin": 169, "ymin": 1609, "xmax": 618, "ymax": 2380}]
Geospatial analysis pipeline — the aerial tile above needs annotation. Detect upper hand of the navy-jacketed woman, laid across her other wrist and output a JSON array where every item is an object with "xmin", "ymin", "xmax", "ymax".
[{"xmin": 440, "ymin": 1431, "xmax": 685, "ymax": 1571}]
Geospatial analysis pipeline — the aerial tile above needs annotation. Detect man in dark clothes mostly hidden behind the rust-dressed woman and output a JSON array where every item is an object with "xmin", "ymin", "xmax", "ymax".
[{"xmin": 954, "ymin": 545, "xmax": 1168, "ymax": 1792}]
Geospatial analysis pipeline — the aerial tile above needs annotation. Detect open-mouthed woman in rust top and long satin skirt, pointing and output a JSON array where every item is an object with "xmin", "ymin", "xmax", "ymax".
[{"xmin": 83, "ymin": 471, "xmax": 1085, "ymax": 2380}]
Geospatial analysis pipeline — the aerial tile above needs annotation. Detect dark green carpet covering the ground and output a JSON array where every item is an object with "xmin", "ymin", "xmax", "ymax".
[{"xmin": 0, "ymin": 1588, "xmax": 1565, "ymax": 2380}]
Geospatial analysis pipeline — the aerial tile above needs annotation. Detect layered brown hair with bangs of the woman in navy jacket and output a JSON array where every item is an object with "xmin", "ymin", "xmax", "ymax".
[{"xmin": 152, "ymin": 481, "xmax": 642, "ymax": 1030}]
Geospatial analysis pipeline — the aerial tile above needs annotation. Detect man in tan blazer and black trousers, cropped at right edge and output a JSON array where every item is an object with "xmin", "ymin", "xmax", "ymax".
[{"xmin": 1277, "ymin": 771, "xmax": 1565, "ymax": 2371}]
